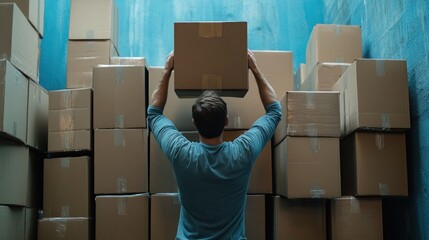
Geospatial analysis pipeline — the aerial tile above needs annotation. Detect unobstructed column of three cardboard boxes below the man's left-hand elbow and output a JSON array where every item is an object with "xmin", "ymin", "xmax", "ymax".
[{"xmin": 93, "ymin": 63, "xmax": 149, "ymax": 239}]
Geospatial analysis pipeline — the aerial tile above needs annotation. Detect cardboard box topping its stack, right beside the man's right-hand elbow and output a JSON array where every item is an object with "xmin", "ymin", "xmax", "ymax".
[{"xmin": 274, "ymin": 91, "xmax": 341, "ymax": 145}]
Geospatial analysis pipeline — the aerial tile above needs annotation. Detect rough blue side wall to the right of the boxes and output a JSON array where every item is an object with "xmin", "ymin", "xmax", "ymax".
[{"xmin": 324, "ymin": 0, "xmax": 429, "ymax": 240}]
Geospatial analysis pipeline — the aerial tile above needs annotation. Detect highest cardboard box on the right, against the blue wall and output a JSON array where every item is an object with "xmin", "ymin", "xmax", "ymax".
[{"xmin": 306, "ymin": 24, "xmax": 362, "ymax": 71}]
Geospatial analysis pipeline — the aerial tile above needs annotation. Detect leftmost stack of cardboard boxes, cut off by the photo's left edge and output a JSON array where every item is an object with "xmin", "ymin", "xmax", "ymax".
[{"xmin": 0, "ymin": 0, "xmax": 48, "ymax": 239}]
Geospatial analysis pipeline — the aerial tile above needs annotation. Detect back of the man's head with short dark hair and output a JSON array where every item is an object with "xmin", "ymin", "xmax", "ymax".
[{"xmin": 192, "ymin": 90, "xmax": 227, "ymax": 138}]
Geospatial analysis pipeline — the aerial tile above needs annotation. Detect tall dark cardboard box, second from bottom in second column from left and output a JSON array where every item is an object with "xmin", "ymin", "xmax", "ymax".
[{"xmin": 43, "ymin": 157, "xmax": 94, "ymax": 218}]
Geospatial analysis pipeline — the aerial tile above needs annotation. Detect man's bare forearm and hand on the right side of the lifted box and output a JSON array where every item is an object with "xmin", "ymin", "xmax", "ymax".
[{"xmin": 247, "ymin": 50, "xmax": 278, "ymax": 107}]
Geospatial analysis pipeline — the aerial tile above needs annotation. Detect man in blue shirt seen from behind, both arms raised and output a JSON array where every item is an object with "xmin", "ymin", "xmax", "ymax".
[{"xmin": 148, "ymin": 51, "xmax": 281, "ymax": 239}]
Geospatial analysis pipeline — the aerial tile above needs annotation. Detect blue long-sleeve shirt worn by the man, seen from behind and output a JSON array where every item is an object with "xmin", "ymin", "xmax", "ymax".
[{"xmin": 148, "ymin": 102, "xmax": 281, "ymax": 240}]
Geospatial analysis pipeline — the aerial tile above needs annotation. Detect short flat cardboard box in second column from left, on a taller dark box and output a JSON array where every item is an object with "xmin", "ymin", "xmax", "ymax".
[{"xmin": 48, "ymin": 130, "xmax": 92, "ymax": 153}]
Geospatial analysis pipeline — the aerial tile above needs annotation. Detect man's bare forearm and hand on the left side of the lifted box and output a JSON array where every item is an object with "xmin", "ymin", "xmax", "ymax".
[{"xmin": 151, "ymin": 51, "xmax": 174, "ymax": 109}]
